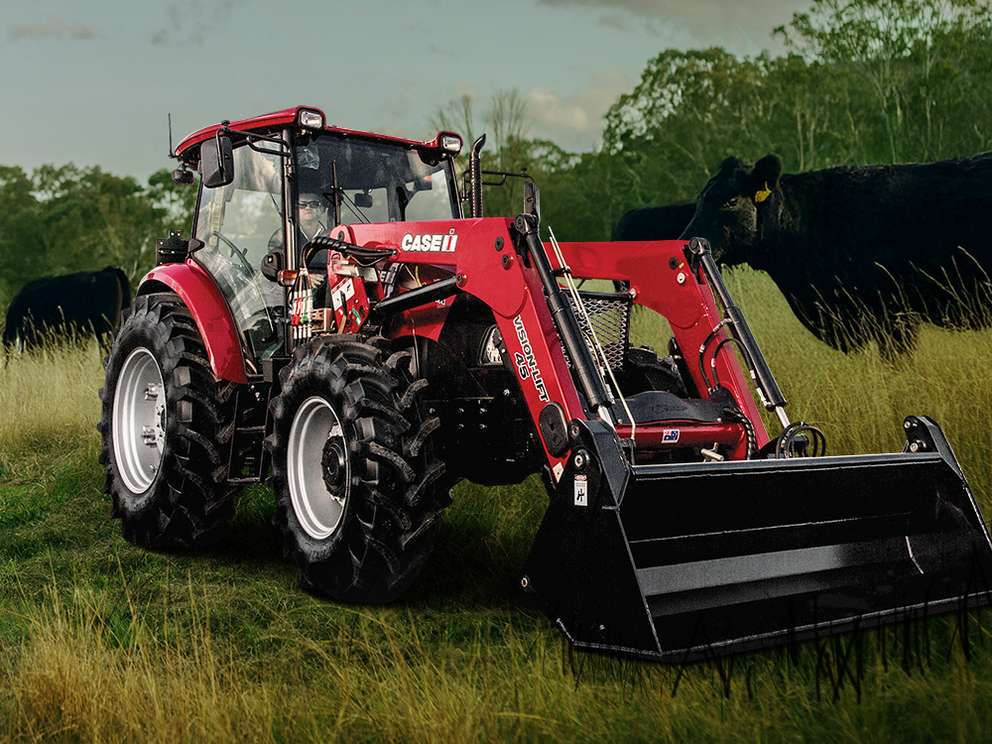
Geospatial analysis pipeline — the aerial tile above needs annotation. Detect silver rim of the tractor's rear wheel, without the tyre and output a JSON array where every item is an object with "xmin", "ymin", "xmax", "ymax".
[{"xmin": 113, "ymin": 346, "xmax": 166, "ymax": 496}]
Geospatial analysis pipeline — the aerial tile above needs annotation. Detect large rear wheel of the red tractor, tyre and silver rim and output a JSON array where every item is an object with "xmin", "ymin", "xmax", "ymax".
[{"xmin": 98, "ymin": 293, "xmax": 237, "ymax": 548}]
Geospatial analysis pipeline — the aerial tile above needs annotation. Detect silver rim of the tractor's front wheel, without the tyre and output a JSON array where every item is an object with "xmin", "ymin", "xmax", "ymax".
[{"xmin": 286, "ymin": 395, "xmax": 351, "ymax": 540}]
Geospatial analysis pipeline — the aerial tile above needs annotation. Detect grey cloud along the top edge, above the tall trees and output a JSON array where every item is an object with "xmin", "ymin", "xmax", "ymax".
[{"xmin": 537, "ymin": 0, "xmax": 811, "ymax": 51}]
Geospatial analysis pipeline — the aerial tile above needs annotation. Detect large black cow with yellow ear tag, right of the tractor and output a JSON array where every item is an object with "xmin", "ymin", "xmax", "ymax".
[{"xmin": 679, "ymin": 154, "xmax": 992, "ymax": 359}]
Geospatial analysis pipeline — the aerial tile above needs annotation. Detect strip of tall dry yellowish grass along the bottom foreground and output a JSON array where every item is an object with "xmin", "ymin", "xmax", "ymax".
[{"xmin": 0, "ymin": 568, "xmax": 992, "ymax": 742}]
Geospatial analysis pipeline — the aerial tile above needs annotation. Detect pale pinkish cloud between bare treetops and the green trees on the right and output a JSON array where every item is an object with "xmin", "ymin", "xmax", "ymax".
[{"xmin": 525, "ymin": 71, "xmax": 632, "ymax": 150}]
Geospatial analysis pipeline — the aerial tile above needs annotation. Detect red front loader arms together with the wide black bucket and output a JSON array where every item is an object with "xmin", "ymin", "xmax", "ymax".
[{"xmin": 339, "ymin": 216, "xmax": 992, "ymax": 661}]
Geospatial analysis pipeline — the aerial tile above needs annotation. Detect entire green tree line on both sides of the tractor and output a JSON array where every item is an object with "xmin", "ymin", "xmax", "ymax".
[{"xmin": 0, "ymin": 0, "xmax": 992, "ymax": 297}]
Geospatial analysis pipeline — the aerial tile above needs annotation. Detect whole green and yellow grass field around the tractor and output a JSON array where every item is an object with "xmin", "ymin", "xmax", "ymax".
[{"xmin": 0, "ymin": 273, "xmax": 992, "ymax": 742}]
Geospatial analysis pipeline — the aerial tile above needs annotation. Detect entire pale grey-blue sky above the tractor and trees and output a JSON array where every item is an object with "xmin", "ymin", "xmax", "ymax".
[{"xmin": 0, "ymin": 0, "xmax": 809, "ymax": 179}]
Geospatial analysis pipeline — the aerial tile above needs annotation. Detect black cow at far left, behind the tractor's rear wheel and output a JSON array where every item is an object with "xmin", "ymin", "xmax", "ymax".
[{"xmin": 3, "ymin": 266, "xmax": 131, "ymax": 349}]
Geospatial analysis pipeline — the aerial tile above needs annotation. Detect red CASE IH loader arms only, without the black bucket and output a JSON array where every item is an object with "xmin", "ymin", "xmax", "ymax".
[{"xmin": 340, "ymin": 218, "xmax": 769, "ymax": 474}]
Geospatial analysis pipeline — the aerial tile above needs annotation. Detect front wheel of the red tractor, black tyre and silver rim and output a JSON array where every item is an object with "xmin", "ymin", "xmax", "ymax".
[{"xmin": 266, "ymin": 336, "xmax": 444, "ymax": 602}]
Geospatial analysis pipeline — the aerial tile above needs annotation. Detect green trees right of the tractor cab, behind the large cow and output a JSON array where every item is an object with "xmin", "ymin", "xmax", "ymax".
[{"xmin": 470, "ymin": 0, "xmax": 992, "ymax": 240}]
